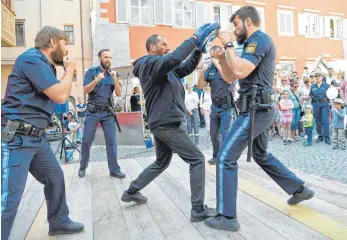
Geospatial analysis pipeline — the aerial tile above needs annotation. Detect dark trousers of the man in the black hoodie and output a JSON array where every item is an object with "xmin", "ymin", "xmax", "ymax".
[{"xmin": 131, "ymin": 123, "xmax": 205, "ymax": 206}]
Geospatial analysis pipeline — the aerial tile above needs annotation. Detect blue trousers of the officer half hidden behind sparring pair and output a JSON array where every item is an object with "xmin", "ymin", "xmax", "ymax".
[{"xmin": 210, "ymin": 104, "xmax": 233, "ymax": 158}]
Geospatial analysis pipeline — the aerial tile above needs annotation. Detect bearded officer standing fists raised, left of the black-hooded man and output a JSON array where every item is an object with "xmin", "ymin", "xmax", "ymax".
[{"xmin": 78, "ymin": 49, "xmax": 125, "ymax": 178}]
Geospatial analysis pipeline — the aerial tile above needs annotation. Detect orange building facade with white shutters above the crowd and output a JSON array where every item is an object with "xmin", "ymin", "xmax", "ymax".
[{"xmin": 92, "ymin": 0, "xmax": 347, "ymax": 83}]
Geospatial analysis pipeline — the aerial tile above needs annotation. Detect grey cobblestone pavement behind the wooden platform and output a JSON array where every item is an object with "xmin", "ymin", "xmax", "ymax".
[{"xmin": 52, "ymin": 128, "xmax": 347, "ymax": 184}]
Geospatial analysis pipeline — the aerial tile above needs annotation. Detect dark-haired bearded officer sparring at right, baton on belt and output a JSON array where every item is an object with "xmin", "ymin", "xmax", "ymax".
[{"xmin": 205, "ymin": 6, "xmax": 314, "ymax": 231}]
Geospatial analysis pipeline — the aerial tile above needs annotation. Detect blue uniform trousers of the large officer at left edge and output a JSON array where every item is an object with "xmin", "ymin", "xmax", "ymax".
[{"xmin": 1, "ymin": 134, "xmax": 71, "ymax": 240}]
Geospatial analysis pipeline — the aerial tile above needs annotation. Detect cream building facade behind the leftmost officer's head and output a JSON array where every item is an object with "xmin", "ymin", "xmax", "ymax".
[{"xmin": 1, "ymin": 0, "xmax": 92, "ymax": 102}]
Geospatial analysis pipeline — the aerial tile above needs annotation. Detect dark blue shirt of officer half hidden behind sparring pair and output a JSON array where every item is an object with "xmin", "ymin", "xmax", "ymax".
[{"xmin": 204, "ymin": 64, "xmax": 231, "ymax": 100}]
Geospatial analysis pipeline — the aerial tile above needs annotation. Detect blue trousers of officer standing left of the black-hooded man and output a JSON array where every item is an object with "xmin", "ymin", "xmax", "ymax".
[{"xmin": 80, "ymin": 111, "xmax": 120, "ymax": 172}]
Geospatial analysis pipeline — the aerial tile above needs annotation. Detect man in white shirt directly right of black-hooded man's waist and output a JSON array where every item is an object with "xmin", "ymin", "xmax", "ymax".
[{"xmin": 184, "ymin": 84, "xmax": 200, "ymax": 144}]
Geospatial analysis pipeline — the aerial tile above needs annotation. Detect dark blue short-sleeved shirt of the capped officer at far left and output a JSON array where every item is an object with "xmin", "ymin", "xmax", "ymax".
[{"xmin": 1, "ymin": 48, "xmax": 59, "ymax": 128}]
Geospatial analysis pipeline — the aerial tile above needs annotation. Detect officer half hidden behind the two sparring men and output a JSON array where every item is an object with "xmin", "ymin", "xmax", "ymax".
[{"xmin": 198, "ymin": 46, "xmax": 233, "ymax": 164}]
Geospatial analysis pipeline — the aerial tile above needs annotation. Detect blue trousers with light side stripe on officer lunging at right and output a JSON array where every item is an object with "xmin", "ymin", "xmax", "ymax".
[{"xmin": 216, "ymin": 109, "xmax": 304, "ymax": 217}]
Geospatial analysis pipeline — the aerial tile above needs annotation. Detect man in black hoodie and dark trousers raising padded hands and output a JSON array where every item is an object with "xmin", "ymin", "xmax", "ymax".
[{"xmin": 121, "ymin": 24, "xmax": 216, "ymax": 222}]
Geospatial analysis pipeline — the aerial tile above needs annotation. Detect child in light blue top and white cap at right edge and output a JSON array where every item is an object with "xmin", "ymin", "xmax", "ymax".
[{"xmin": 331, "ymin": 98, "xmax": 346, "ymax": 150}]
